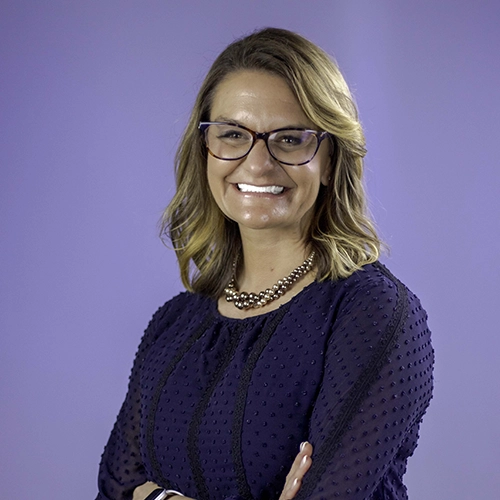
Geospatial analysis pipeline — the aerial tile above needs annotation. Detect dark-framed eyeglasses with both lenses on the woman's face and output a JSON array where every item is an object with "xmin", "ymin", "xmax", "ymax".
[{"xmin": 198, "ymin": 122, "xmax": 328, "ymax": 165}]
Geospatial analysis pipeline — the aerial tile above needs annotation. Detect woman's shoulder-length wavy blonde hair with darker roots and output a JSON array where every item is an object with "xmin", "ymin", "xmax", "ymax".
[{"xmin": 161, "ymin": 28, "xmax": 381, "ymax": 298}]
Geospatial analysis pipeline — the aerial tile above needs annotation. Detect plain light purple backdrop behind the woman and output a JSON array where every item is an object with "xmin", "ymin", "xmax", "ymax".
[{"xmin": 0, "ymin": 0, "xmax": 500, "ymax": 500}]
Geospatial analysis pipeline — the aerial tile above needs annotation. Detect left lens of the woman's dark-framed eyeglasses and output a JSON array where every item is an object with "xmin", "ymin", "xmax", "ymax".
[{"xmin": 205, "ymin": 123, "xmax": 253, "ymax": 160}]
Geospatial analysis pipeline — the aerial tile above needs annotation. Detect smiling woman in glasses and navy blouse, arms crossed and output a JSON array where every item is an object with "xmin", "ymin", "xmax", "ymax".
[{"xmin": 98, "ymin": 29, "xmax": 433, "ymax": 500}]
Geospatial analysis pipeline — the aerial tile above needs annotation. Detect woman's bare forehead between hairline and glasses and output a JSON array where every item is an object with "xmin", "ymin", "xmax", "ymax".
[{"xmin": 210, "ymin": 70, "xmax": 313, "ymax": 131}]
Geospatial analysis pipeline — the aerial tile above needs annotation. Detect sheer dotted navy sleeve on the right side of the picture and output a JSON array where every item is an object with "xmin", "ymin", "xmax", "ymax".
[{"xmin": 296, "ymin": 266, "xmax": 433, "ymax": 500}]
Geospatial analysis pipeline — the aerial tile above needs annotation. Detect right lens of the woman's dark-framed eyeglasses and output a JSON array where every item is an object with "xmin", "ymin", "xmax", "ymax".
[{"xmin": 268, "ymin": 129, "xmax": 318, "ymax": 165}]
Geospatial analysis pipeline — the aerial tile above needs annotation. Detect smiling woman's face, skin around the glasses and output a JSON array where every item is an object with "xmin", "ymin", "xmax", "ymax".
[{"xmin": 207, "ymin": 70, "xmax": 331, "ymax": 238}]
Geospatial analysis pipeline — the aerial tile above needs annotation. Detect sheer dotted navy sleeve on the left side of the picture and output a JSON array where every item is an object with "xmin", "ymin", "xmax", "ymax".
[{"xmin": 96, "ymin": 302, "xmax": 174, "ymax": 500}]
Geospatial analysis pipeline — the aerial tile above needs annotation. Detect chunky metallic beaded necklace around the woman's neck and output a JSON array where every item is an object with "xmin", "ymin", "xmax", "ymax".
[{"xmin": 224, "ymin": 252, "xmax": 314, "ymax": 309}]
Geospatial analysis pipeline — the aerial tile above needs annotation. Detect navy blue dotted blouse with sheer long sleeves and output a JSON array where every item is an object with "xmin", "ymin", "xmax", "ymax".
[{"xmin": 97, "ymin": 264, "xmax": 433, "ymax": 500}]
